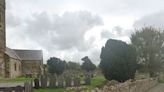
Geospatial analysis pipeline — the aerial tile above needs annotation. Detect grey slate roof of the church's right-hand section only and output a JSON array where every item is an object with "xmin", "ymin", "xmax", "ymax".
[{"xmin": 14, "ymin": 49, "xmax": 43, "ymax": 60}]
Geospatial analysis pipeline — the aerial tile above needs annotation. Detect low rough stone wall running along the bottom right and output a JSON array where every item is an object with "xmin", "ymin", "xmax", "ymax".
[{"xmin": 82, "ymin": 79, "xmax": 158, "ymax": 92}]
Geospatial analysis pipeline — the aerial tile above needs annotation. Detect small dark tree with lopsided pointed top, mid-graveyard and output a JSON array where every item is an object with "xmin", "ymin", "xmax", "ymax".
[{"xmin": 81, "ymin": 56, "xmax": 96, "ymax": 72}]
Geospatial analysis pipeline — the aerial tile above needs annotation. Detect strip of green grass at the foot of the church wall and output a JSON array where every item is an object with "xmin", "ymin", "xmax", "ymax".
[{"xmin": 0, "ymin": 77, "xmax": 32, "ymax": 83}]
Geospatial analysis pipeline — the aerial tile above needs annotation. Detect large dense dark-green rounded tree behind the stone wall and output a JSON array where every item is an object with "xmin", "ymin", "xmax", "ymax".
[{"xmin": 100, "ymin": 39, "xmax": 137, "ymax": 82}]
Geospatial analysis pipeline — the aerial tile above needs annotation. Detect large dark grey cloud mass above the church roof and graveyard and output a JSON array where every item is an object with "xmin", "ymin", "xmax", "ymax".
[{"xmin": 25, "ymin": 11, "xmax": 103, "ymax": 51}]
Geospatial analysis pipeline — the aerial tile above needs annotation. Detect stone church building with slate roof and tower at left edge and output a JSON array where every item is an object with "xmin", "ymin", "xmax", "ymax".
[{"xmin": 0, "ymin": 0, "xmax": 43, "ymax": 78}]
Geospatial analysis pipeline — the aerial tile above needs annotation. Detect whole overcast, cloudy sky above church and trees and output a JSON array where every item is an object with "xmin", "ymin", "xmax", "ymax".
[{"xmin": 6, "ymin": 0, "xmax": 164, "ymax": 64}]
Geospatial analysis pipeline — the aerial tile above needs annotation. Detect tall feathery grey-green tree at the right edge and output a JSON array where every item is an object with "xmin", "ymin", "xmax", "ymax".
[{"xmin": 131, "ymin": 27, "xmax": 164, "ymax": 77}]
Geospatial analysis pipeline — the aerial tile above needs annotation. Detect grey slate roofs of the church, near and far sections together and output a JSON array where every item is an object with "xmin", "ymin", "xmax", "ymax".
[{"xmin": 5, "ymin": 47, "xmax": 43, "ymax": 60}]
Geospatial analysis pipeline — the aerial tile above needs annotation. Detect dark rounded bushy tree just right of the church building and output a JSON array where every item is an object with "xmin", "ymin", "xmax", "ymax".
[{"xmin": 47, "ymin": 57, "xmax": 65, "ymax": 75}]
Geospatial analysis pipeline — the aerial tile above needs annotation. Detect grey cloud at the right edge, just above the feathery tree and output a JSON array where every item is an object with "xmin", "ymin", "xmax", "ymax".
[{"xmin": 133, "ymin": 11, "xmax": 164, "ymax": 29}]
